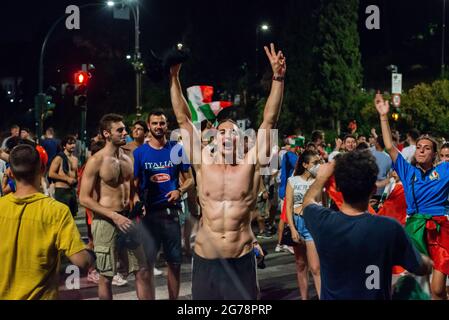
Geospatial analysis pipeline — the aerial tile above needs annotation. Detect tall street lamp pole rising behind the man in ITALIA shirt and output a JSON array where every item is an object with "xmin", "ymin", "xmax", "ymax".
[{"xmin": 107, "ymin": 0, "xmax": 143, "ymax": 119}]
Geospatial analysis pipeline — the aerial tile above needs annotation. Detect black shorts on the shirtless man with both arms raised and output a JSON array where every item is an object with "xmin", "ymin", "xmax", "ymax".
[{"xmin": 192, "ymin": 251, "xmax": 259, "ymax": 300}]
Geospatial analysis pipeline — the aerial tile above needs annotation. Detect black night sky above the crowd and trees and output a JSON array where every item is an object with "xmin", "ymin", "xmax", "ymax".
[{"xmin": 0, "ymin": 0, "xmax": 449, "ymax": 132}]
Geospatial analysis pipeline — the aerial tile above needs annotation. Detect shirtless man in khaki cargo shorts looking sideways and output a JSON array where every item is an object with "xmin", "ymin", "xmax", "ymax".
[{"xmin": 80, "ymin": 114, "xmax": 151, "ymax": 299}]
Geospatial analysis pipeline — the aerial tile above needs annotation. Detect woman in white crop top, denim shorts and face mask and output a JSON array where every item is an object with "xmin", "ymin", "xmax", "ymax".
[{"xmin": 285, "ymin": 150, "xmax": 321, "ymax": 300}]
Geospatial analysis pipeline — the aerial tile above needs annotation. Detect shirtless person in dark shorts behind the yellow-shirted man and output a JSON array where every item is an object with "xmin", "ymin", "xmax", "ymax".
[{"xmin": 48, "ymin": 135, "xmax": 78, "ymax": 216}]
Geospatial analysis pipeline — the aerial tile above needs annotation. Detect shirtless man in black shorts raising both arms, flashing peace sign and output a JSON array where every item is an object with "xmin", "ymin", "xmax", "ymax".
[{"xmin": 170, "ymin": 44, "xmax": 286, "ymax": 300}]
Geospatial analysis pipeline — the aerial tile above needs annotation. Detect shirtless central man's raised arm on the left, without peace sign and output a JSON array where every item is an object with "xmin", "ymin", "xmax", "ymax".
[{"xmin": 170, "ymin": 64, "xmax": 201, "ymax": 164}]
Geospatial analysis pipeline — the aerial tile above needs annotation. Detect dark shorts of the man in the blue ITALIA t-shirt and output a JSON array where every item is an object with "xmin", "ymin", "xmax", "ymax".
[{"xmin": 142, "ymin": 208, "xmax": 182, "ymax": 264}]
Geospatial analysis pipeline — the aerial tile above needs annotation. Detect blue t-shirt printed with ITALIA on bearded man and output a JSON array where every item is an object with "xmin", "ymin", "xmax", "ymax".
[{"xmin": 133, "ymin": 141, "xmax": 190, "ymax": 209}]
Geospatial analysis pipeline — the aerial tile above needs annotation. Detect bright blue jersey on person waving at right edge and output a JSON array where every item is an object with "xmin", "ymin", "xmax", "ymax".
[{"xmin": 393, "ymin": 153, "xmax": 449, "ymax": 216}]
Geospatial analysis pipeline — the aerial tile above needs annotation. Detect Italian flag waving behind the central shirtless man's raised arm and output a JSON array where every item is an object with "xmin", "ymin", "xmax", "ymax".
[{"xmin": 187, "ymin": 86, "xmax": 232, "ymax": 123}]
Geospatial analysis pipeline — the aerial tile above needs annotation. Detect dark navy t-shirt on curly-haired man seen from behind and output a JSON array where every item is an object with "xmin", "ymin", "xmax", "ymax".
[{"xmin": 303, "ymin": 204, "xmax": 422, "ymax": 300}]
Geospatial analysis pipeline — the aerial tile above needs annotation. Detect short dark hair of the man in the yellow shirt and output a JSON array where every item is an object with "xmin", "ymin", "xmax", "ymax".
[{"xmin": 9, "ymin": 144, "xmax": 41, "ymax": 183}]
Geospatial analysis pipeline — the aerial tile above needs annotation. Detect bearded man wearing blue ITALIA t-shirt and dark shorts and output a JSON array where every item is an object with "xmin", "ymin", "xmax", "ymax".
[{"xmin": 133, "ymin": 112, "xmax": 193, "ymax": 299}]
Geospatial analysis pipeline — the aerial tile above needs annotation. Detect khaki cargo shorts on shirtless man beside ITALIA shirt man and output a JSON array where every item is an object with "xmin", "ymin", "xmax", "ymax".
[{"xmin": 92, "ymin": 214, "xmax": 148, "ymax": 278}]
